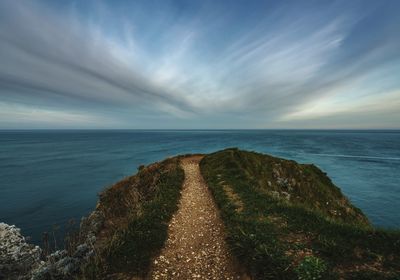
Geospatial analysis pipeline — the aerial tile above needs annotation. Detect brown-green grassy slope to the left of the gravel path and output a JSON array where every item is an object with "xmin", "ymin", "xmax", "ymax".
[{"xmin": 83, "ymin": 158, "xmax": 184, "ymax": 279}]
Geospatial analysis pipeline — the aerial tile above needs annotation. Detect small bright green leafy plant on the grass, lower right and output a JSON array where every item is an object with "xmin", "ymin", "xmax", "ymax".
[{"xmin": 295, "ymin": 256, "xmax": 327, "ymax": 280}]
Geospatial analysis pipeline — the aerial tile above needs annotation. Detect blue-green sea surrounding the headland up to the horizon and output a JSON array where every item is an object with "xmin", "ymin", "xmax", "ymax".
[{"xmin": 0, "ymin": 130, "xmax": 400, "ymax": 243}]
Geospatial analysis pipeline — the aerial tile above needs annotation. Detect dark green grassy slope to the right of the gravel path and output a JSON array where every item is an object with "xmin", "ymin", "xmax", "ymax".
[{"xmin": 200, "ymin": 149, "xmax": 400, "ymax": 279}]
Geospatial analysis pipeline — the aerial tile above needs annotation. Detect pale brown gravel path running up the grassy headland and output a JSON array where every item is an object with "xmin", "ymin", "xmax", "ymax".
[{"xmin": 150, "ymin": 156, "xmax": 242, "ymax": 279}]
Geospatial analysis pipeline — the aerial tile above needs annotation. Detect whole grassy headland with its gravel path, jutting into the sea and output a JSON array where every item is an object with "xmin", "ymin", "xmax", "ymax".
[{"xmin": 0, "ymin": 148, "xmax": 400, "ymax": 280}]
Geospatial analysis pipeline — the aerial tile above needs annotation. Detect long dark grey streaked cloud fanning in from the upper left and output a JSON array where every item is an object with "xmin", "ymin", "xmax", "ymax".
[{"xmin": 0, "ymin": 1, "xmax": 194, "ymax": 116}]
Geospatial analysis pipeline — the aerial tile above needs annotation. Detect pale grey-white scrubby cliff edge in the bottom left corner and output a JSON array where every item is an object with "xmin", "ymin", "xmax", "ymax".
[{"xmin": 0, "ymin": 211, "xmax": 103, "ymax": 280}]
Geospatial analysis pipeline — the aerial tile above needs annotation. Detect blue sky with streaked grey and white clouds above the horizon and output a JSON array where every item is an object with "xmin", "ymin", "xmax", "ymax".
[{"xmin": 0, "ymin": 0, "xmax": 400, "ymax": 129}]
